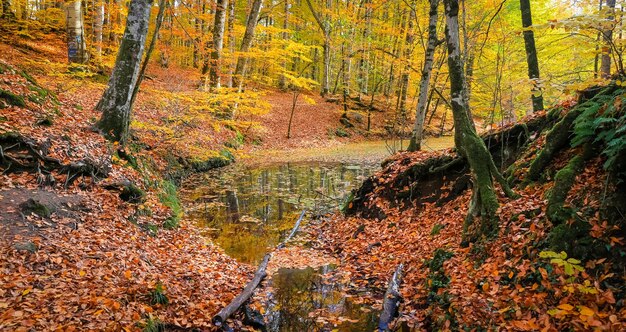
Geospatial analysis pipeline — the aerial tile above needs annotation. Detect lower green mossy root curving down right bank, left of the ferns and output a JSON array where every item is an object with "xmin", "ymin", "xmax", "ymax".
[{"xmin": 546, "ymin": 155, "xmax": 584, "ymax": 225}]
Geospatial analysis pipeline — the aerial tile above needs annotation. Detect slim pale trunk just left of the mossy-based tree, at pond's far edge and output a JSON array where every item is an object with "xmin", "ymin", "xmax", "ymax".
[{"xmin": 407, "ymin": 0, "xmax": 439, "ymax": 151}]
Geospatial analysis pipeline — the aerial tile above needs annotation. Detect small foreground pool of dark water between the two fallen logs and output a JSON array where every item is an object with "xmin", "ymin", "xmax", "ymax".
[{"xmin": 265, "ymin": 266, "xmax": 378, "ymax": 332}]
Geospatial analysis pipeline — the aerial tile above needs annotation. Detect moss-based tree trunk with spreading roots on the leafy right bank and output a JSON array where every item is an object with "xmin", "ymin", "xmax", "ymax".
[{"xmin": 444, "ymin": 0, "xmax": 514, "ymax": 244}]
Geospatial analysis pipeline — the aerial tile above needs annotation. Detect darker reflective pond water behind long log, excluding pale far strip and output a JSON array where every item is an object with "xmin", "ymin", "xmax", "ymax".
[{"xmin": 183, "ymin": 164, "xmax": 377, "ymax": 264}]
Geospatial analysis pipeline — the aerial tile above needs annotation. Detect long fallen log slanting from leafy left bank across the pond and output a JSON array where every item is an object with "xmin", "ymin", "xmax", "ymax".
[{"xmin": 212, "ymin": 209, "xmax": 306, "ymax": 330}]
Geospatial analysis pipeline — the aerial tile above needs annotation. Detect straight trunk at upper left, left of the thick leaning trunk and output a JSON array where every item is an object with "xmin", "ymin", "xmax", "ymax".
[{"xmin": 65, "ymin": 0, "xmax": 88, "ymax": 63}]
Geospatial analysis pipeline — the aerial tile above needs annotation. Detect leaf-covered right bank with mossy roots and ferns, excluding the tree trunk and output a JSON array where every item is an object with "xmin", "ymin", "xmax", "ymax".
[{"xmin": 316, "ymin": 86, "xmax": 626, "ymax": 331}]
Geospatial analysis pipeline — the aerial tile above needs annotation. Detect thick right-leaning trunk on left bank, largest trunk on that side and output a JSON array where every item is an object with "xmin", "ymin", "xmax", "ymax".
[{"xmin": 96, "ymin": 0, "xmax": 152, "ymax": 143}]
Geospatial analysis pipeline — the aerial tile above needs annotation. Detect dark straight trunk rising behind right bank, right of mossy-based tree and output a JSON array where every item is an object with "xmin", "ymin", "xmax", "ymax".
[{"xmin": 520, "ymin": 0, "xmax": 543, "ymax": 112}]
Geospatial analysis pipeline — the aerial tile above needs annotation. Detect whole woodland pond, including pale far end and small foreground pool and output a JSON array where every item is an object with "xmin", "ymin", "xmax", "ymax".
[{"xmin": 181, "ymin": 137, "xmax": 453, "ymax": 332}]
